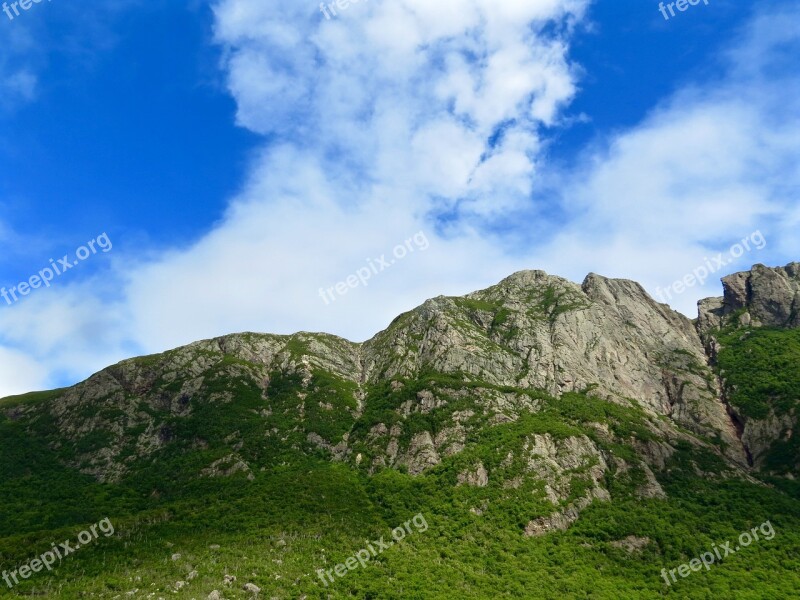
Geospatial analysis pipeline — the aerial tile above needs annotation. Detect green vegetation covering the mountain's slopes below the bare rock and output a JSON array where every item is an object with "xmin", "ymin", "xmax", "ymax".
[{"xmin": 0, "ymin": 338, "xmax": 800, "ymax": 600}]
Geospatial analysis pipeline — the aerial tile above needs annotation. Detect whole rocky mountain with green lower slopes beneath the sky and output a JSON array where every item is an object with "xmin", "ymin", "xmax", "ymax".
[{"xmin": 0, "ymin": 263, "xmax": 800, "ymax": 599}]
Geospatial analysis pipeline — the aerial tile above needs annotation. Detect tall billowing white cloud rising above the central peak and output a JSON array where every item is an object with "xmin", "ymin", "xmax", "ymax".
[{"xmin": 111, "ymin": 0, "xmax": 584, "ymax": 350}]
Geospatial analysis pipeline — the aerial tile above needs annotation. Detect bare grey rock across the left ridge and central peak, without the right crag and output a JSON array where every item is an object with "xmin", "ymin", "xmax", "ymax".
[{"xmin": 1, "ymin": 271, "xmax": 744, "ymax": 481}]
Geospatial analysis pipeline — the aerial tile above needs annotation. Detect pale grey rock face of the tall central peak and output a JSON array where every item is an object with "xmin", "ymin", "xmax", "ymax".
[{"xmin": 364, "ymin": 271, "xmax": 746, "ymax": 464}]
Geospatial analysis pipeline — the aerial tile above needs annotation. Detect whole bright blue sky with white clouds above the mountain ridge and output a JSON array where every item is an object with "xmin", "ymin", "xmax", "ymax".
[{"xmin": 0, "ymin": 0, "xmax": 800, "ymax": 396}]
